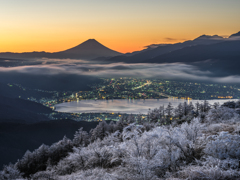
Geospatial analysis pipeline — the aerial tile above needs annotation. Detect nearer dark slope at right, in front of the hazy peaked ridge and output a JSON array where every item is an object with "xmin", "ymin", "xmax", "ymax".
[{"xmin": 143, "ymin": 41, "xmax": 240, "ymax": 75}]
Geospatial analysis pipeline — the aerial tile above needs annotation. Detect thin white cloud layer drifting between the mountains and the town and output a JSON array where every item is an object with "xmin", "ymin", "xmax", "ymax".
[{"xmin": 0, "ymin": 60, "xmax": 240, "ymax": 83}]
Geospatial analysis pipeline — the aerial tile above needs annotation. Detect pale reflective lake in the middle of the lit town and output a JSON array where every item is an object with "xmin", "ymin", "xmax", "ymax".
[{"xmin": 55, "ymin": 98, "xmax": 236, "ymax": 114}]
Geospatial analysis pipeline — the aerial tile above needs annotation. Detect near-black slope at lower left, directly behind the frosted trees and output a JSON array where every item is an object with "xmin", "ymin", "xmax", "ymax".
[{"xmin": 0, "ymin": 120, "xmax": 98, "ymax": 169}]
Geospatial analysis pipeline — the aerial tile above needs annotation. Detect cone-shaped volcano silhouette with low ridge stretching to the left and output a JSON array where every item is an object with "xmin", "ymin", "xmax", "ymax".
[{"xmin": 0, "ymin": 39, "xmax": 121, "ymax": 60}]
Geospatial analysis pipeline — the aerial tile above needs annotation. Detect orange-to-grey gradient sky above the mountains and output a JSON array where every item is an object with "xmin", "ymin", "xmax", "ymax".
[{"xmin": 0, "ymin": 0, "xmax": 240, "ymax": 53}]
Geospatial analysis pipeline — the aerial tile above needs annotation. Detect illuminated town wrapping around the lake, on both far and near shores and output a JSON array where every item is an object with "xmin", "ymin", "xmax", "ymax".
[{"xmin": 8, "ymin": 78, "xmax": 240, "ymax": 121}]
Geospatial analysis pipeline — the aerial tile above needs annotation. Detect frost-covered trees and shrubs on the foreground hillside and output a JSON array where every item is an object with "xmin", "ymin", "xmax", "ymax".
[{"xmin": 0, "ymin": 100, "xmax": 240, "ymax": 180}]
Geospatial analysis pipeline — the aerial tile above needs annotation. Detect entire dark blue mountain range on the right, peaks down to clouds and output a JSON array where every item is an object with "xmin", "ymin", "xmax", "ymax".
[{"xmin": 104, "ymin": 32, "xmax": 240, "ymax": 76}]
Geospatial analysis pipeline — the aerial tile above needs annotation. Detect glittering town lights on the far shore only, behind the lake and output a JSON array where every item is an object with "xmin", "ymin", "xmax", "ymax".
[{"xmin": 40, "ymin": 78, "xmax": 240, "ymax": 106}]
